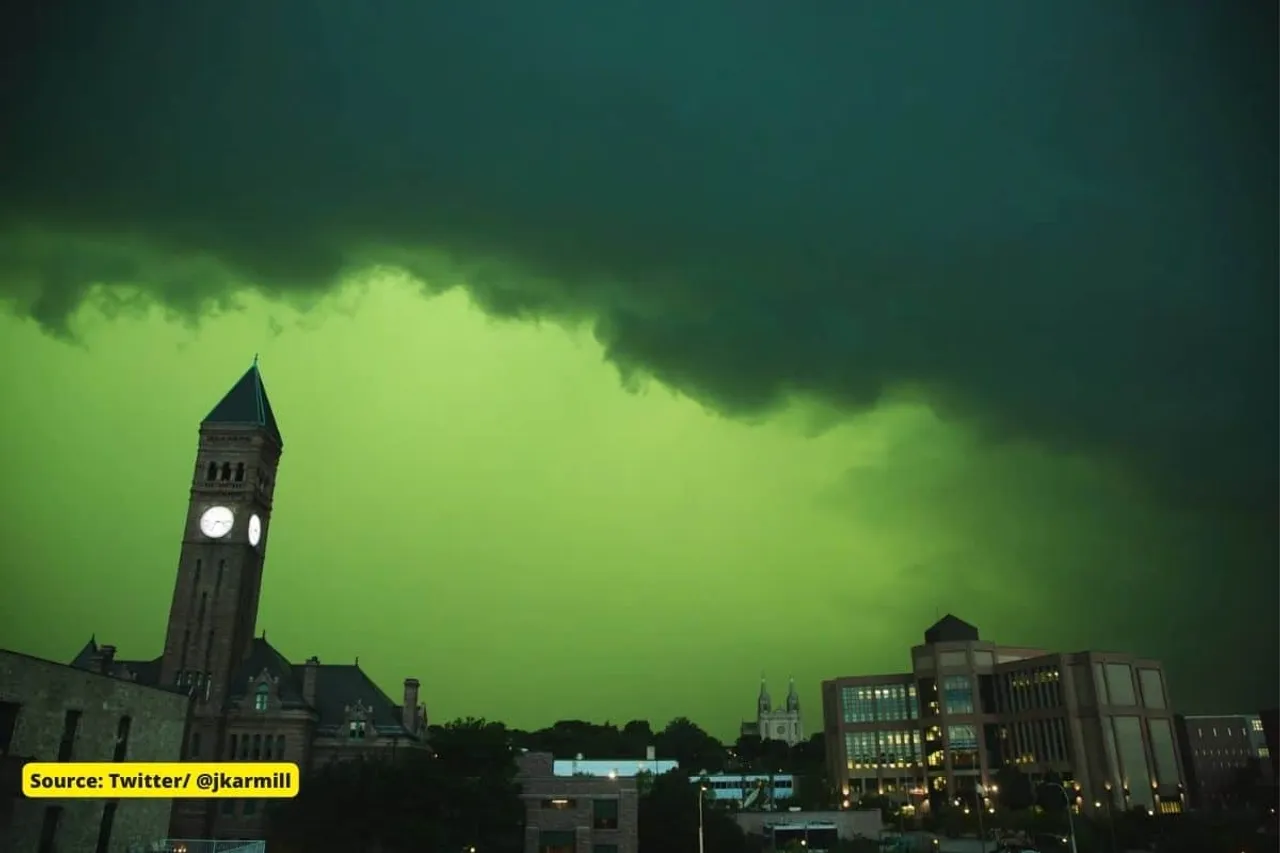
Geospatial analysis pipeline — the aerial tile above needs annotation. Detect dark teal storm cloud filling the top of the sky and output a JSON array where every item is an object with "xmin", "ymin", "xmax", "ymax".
[{"xmin": 0, "ymin": 0, "xmax": 1277, "ymax": 507}]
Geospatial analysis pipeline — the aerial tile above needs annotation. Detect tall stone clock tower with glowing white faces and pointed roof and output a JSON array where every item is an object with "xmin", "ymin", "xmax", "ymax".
[{"xmin": 160, "ymin": 359, "xmax": 284, "ymax": 716}]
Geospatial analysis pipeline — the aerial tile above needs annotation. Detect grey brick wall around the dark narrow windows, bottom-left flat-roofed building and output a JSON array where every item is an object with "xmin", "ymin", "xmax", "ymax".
[{"xmin": 0, "ymin": 651, "xmax": 187, "ymax": 853}]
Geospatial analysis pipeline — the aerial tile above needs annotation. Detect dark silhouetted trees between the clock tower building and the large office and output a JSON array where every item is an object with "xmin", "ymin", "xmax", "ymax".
[{"xmin": 268, "ymin": 717, "xmax": 831, "ymax": 853}]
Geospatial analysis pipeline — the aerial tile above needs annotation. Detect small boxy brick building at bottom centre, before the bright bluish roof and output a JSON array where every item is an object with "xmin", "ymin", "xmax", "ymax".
[{"xmin": 516, "ymin": 752, "xmax": 645, "ymax": 853}]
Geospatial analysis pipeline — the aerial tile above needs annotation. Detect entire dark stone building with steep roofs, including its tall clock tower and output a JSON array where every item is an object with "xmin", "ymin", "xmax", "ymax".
[{"xmin": 72, "ymin": 360, "xmax": 426, "ymax": 839}]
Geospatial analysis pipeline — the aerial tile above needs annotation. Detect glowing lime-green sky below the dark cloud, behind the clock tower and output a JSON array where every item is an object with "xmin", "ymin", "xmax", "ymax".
[{"xmin": 0, "ymin": 268, "xmax": 1248, "ymax": 736}]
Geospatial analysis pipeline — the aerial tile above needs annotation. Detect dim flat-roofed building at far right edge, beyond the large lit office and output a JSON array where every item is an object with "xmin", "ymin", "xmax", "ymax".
[{"xmin": 1174, "ymin": 713, "xmax": 1272, "ymax": 811}]
